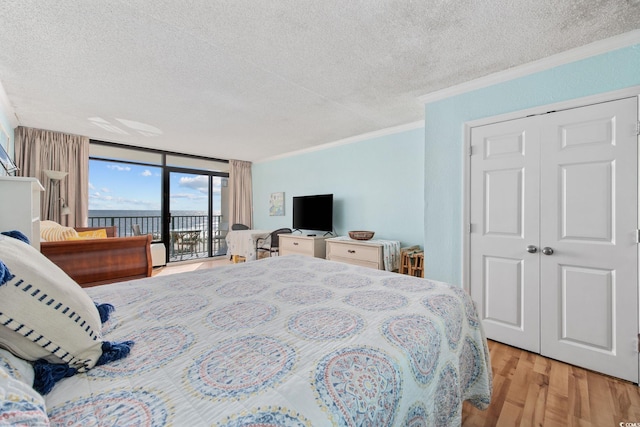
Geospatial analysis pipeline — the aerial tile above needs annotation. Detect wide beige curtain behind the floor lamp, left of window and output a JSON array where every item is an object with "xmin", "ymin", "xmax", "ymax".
[{"xmin": 15, "ymin": 126, "xmax": 89, "ymax": 227}]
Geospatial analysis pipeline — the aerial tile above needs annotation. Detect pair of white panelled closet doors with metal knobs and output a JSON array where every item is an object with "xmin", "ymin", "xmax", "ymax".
[{"xmin": 469, "ymin": 97, "xmax": 638, "ymax": 382}]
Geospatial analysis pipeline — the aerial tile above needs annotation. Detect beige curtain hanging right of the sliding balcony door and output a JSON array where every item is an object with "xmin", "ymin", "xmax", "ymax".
[{"xmin": 229, "ymin": 160, "xmax": 253, "ymax": 228}]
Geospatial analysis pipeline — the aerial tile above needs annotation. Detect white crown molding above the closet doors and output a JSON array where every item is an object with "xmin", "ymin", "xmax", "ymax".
[{"xmin": 418, "ymin": 30, "xmax": 640, "ymax": 104}]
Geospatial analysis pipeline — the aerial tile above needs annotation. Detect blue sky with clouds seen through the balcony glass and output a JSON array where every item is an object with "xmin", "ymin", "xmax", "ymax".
[{"xmin": 89, "ymin": 160, "xmax": 221, "ymax": 215}]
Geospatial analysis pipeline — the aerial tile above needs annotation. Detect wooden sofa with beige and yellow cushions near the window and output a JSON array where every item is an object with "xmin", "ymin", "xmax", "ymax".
[{"xmin": 40, "ymin": 221, "xmax": 153, "ymax": 287}]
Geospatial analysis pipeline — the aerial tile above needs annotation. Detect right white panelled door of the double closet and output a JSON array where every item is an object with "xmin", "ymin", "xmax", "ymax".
[{"xmin": 540, "ymin": 98, "xmax": 638, "ymax": 382}]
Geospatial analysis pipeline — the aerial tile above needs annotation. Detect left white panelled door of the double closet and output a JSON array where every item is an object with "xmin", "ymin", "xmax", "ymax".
[{"xmin": 470, "ymin": 119, "xmax": 540, "ymax": 352}]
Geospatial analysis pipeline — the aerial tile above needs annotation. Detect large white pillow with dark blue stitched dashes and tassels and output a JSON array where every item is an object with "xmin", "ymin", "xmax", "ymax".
[{"xmin": 0, "ymin": 235, "xmax": 102, "ymax": 372}]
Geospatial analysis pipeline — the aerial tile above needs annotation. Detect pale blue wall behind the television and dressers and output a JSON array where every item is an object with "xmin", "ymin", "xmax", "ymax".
[{"xmin": 252, "ymin": 128, "xmax": 424, "ymax": 246}]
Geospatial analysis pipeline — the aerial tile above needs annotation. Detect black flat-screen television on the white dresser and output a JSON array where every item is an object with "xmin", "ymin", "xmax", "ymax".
[{"xmin": 293, "ymin": 194, "xmax": 333, "ymax": 232}]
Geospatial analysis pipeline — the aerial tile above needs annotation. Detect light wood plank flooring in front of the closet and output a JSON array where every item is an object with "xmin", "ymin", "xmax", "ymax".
[{"xmin": 462, "ymin": 341, "xmax": 640, "ymax": 427}]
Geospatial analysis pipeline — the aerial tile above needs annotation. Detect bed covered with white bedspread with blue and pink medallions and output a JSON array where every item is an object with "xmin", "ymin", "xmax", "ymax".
[{"xmin": 40, "ymin": 255, "xmax": 491, "ymax": 427}]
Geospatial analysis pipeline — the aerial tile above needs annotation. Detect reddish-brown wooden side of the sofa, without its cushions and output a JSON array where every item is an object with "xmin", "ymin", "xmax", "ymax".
[{"xmin": 40, "ymin": 235, "xmax": 153, "ymax": 287}]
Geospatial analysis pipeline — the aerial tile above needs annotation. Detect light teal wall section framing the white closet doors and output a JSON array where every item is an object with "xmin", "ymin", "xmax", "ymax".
[{"xmin": 424, "ymin": 45, "xmax": 640, "ymax": 284}]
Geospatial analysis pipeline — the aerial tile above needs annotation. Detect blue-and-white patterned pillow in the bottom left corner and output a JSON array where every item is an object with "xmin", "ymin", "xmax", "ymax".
[{"xmin": 0, "ymin": 365, "xmax": 49, "ymax": 427}]
